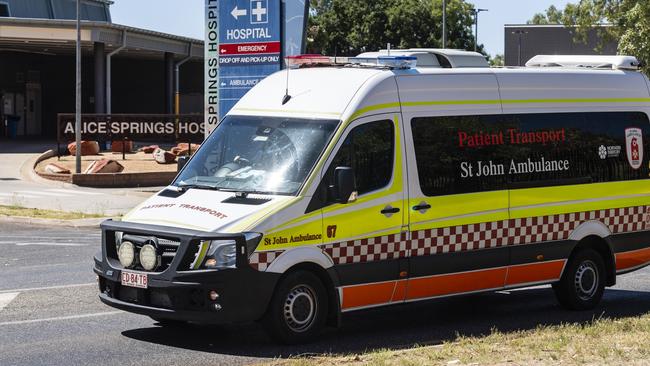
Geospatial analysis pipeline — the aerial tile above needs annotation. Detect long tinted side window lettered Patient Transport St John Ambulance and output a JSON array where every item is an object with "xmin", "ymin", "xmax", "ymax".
[{"xmin": 411, "ymin": 112, "xmax": 650, "ymax": 196}]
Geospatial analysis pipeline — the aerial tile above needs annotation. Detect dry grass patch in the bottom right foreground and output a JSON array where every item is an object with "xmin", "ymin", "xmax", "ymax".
[{"xmin": 272, "ymin": 315, "xmax": 650, "ymax": 366}]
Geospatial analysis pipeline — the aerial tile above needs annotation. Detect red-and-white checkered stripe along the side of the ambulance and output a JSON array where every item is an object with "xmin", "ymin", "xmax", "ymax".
[{"xmin": 250, "ymin": 206, "xmax": 650, "ymax": 271}]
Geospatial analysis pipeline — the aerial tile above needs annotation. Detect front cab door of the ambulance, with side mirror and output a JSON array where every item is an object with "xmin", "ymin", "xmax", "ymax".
[{"xmin": 308, "ymin": 113, "xmax": 407, "ymax": 311}]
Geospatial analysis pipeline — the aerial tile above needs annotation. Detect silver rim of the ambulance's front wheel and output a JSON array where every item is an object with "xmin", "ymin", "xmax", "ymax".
[{"xmin": 283, "ymin": 285, "xmax": 318, "ymax": 332}]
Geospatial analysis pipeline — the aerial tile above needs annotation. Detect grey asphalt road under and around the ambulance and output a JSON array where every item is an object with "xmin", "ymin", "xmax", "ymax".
[{"xmin": 0, "ymin": 223, "xmax": 650, "ymax": 366}]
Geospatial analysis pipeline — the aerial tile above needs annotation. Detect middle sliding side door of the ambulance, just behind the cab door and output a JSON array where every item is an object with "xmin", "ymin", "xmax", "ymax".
[{"xmin": 398, "ymin": 74, "xmax": 510, "ymax": 301}]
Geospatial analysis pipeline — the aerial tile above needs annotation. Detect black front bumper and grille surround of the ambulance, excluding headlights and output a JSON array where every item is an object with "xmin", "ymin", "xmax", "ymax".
[{"xmin": 94, "ymin": 221, "xmax": 280, "ymax": 324}]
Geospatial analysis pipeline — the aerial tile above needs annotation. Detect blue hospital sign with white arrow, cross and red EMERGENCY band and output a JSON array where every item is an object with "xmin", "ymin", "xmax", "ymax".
[{"xmin": 219, "ymin": 0, "xmax": 281, "ymax": 118}]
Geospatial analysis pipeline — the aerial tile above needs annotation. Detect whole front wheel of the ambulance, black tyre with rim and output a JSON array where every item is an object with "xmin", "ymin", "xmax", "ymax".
[{"xmin": 262, "ymin": 271, "xmax": 328, "ymax": 344}]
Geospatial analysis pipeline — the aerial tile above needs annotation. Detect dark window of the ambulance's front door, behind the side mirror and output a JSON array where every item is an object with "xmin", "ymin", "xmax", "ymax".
[{"xmin": 326, "ymin": 120, "xmax": 395, "ymax": 194}]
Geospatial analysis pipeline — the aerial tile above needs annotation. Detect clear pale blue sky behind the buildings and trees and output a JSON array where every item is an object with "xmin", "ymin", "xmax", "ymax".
[{"xmin": 111, "ymin": 0, "xmax": 576, "ymax": 55}]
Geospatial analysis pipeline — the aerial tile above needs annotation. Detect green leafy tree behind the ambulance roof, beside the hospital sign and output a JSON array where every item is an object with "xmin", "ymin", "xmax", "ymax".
[{"xmin": 307, "ymin": 0, "xmax": 483, "ymax": 56}]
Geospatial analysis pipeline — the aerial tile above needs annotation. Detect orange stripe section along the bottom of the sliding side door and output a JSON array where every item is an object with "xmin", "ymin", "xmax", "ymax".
[{"xmin": 406, "ymin": 268, "xmax": 507, "ymax": 300}]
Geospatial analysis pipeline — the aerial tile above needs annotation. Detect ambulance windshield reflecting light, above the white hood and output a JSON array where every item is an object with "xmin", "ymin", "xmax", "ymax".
[{"xmin": 174, "ymin": 116, "xmax": 338, "ymax": 195}]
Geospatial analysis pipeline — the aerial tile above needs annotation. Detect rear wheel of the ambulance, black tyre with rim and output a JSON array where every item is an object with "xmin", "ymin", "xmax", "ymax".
[{"xmin": 553, "ymin": 249, "xmax": 606, "ymax": 310}]
